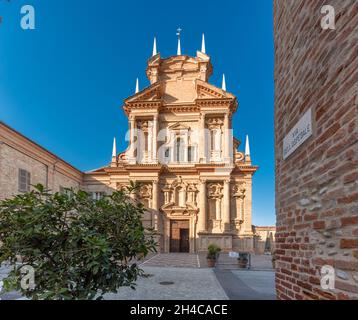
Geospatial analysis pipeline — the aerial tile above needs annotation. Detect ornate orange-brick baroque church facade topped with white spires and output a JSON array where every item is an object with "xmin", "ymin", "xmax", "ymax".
[{"xmin": 83, "ymin": 36, "xmax": 258, "ymax": 252}]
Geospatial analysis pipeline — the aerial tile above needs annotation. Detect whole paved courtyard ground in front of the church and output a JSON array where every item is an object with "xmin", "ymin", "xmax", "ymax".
[{"xmin": 0, "ymin": 253, "xmax": 275, "ymax": 300}]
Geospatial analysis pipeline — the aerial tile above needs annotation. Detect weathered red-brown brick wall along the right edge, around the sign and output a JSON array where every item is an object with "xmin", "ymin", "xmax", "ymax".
[{"xmin": 274, "ymin": 0, "xmax": 358, "ymax": 299}]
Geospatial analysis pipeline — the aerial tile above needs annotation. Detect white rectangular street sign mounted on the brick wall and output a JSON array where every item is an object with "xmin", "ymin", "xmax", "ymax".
[{"xmin": 283, "ymin": 108, "xmax": 312, "ymax": 160}]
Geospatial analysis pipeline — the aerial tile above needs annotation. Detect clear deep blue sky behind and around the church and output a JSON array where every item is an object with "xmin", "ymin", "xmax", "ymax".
[{"xmin": 0, "ymin": 0, "xmax": 275, "ymax": 225}]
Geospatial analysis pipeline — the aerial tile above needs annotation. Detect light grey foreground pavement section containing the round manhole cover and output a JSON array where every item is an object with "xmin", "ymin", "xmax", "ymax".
[{"xmin": 105, "ymin": 265, "xmax": 228, "ymax": 300}]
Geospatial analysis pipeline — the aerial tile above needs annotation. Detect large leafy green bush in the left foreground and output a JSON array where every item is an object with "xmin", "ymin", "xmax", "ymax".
[{"xmin": 0, "ymin": 184, "xmax": 155, "ymax": 299}]
